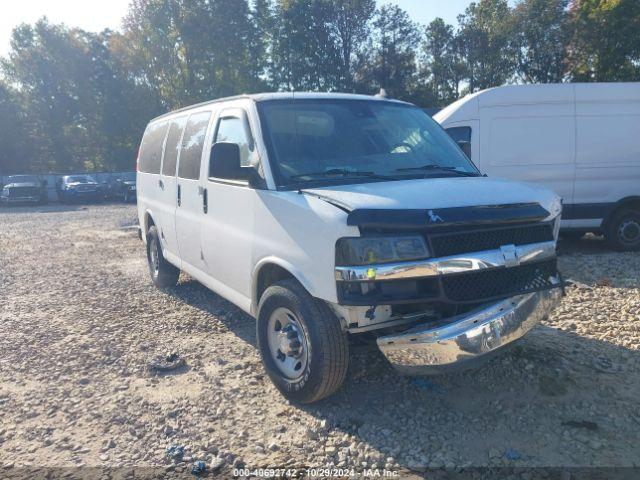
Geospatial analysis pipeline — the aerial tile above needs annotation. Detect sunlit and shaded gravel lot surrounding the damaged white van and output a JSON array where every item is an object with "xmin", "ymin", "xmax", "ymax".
[{"xmin": 0, "ymin": 205, "xmax": 640, "ymax": 478}]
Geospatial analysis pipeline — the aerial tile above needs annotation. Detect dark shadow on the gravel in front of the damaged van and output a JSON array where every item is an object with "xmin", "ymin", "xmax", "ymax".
[{"xmin": 301, "ymin": 326, "xmax": 640, "ymax": 469}]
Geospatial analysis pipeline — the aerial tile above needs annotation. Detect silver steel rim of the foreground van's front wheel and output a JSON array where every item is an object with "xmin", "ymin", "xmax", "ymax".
[{"xmin": 267, "ymin": 307, "xmax": 309, "ymax": 380}]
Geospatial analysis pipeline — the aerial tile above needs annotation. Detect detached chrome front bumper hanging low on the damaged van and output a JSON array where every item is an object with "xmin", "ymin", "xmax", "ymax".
[{"xmin": 377, "ymin": 288, "xmax": 562, "ymax": 375}]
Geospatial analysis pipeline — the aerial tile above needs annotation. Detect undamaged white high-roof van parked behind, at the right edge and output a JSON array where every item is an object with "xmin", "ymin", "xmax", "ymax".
[{"xmin": 434, "ymin": 83, "xmax": 640, "ymax": 250}]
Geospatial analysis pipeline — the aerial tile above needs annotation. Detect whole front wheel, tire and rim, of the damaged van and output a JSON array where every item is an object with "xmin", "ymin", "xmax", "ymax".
[{"xmin": 257, "ymin": 280, "xmax": 349, "ymax": 403}]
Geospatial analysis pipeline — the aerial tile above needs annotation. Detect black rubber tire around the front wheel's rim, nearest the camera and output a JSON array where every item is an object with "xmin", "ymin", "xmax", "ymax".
[{"xmin": 257, "ymin": 280, "xmax": 349, "ymax": 403}]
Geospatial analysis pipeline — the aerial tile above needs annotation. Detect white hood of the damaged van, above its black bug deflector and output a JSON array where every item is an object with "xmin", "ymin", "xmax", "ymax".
[{"xmin": 302, "ymin": 177, "xmax": 561, "ymax": 226}]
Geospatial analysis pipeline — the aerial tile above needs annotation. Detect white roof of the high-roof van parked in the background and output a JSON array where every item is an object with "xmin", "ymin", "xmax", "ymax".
[{"xmin": 434, "ymin": 82, "xmax": 640, "ymax": 122}]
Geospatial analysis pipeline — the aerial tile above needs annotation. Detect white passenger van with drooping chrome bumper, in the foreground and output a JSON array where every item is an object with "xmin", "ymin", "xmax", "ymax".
[{"xmin": 137, "ymin": 93, "xmax": 562, "ymax": 402}]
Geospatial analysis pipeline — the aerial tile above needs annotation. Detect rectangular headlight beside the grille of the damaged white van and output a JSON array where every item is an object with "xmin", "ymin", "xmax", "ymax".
[{"xmin": 336, "ymin": 235, "xmax": 429, "ymax": 266}]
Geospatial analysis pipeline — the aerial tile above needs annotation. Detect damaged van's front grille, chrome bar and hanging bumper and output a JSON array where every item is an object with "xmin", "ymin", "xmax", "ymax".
[{"xmin": 334, "ymin": 206, "xmax": 563, "ymax": 375}]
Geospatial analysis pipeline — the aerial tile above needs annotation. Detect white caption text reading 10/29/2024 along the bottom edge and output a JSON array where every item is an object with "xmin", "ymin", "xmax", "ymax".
[{"xmin": 233, "ymin": 467, "xmax": 400, "ymax": 478}]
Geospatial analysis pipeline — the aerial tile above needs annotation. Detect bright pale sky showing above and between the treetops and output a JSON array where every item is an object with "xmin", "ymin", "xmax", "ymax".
[{"xmin": 0, "ymin": 0, "xmax": 480, "ymax": 55}]
